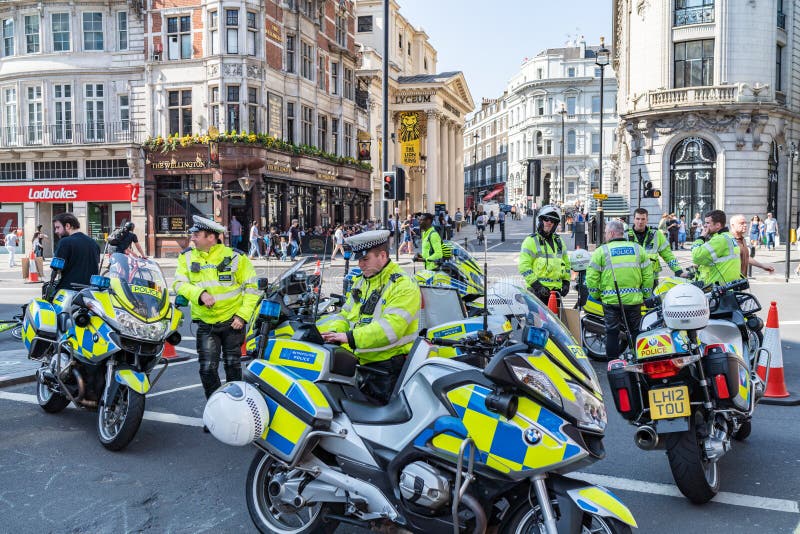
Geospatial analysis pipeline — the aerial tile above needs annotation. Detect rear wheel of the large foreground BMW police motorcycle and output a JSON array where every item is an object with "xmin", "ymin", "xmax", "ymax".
[{"xmin": 246, "ymin": 450, "xmax": 338, "ymax": 534}]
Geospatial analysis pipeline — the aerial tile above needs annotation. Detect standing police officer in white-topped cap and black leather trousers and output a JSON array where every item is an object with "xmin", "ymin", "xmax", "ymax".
[{"xmin": 172, "ymin": 215, "xmax": 259, "ymax": 414}]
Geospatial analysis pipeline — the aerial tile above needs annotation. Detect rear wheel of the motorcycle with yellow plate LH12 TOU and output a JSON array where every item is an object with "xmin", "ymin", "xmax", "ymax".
[{"xmin": 667, "ymin": 430, "xmax": 719, "ymax": 504}]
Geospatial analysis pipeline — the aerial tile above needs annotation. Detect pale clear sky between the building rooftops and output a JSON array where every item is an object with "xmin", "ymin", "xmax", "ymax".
[{"xmin": 397, "ymin": 0, "xmax": 611, "ymax": 114}]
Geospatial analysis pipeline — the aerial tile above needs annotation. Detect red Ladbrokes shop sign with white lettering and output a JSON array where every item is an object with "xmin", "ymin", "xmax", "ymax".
[{"xmin": 0, "ymin": 184, "xmax": 138, "ymax": 202}]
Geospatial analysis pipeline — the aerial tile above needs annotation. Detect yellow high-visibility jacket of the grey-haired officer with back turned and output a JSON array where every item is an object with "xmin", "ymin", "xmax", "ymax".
[{"xmin": 586, "ymin": 237, "xmax": 653, "ymax": 305}]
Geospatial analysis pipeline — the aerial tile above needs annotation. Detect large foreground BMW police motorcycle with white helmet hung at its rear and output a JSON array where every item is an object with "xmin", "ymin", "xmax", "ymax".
[{"xmin": 203, "ymin": 289, "xmax": 636, "ymax": 534}]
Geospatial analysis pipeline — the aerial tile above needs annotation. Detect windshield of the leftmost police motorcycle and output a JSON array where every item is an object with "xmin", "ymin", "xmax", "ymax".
[{"xmin": 106, "ymin": 253, "xmax": 169, "ymax": 321}]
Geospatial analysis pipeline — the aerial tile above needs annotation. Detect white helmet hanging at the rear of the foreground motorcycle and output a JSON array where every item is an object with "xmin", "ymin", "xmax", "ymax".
[{"xmin": 203, "ymin": 381, "xmax": 269, "ymax": 447}]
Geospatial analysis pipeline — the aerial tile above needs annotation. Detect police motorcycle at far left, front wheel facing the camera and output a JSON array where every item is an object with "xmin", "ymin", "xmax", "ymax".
[{"xmin": 23, "ymin": 253, "xmax": 183, "ymax": 451}]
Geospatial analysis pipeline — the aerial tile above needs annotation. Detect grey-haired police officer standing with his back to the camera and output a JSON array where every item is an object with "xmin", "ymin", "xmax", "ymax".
[{"xmin": 586, "ymin": 220, "xmax": 653, "ymax": 360}]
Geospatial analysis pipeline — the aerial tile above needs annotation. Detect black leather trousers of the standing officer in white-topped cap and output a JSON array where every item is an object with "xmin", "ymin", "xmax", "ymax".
[{"xmin": 197, "ymin": 318, "xmax": 245, "ymax": 398}]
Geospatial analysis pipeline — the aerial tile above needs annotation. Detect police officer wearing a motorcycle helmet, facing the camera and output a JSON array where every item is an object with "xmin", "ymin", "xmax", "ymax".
[{"xmin": 518, "ymin": 206, "xmax": 570, "ymax": 304}]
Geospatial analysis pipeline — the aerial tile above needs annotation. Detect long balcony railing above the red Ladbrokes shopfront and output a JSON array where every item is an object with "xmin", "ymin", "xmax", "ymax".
[{"xmin": 0, "ymin": 121, "xmax": 146, "ymax": 148}]
